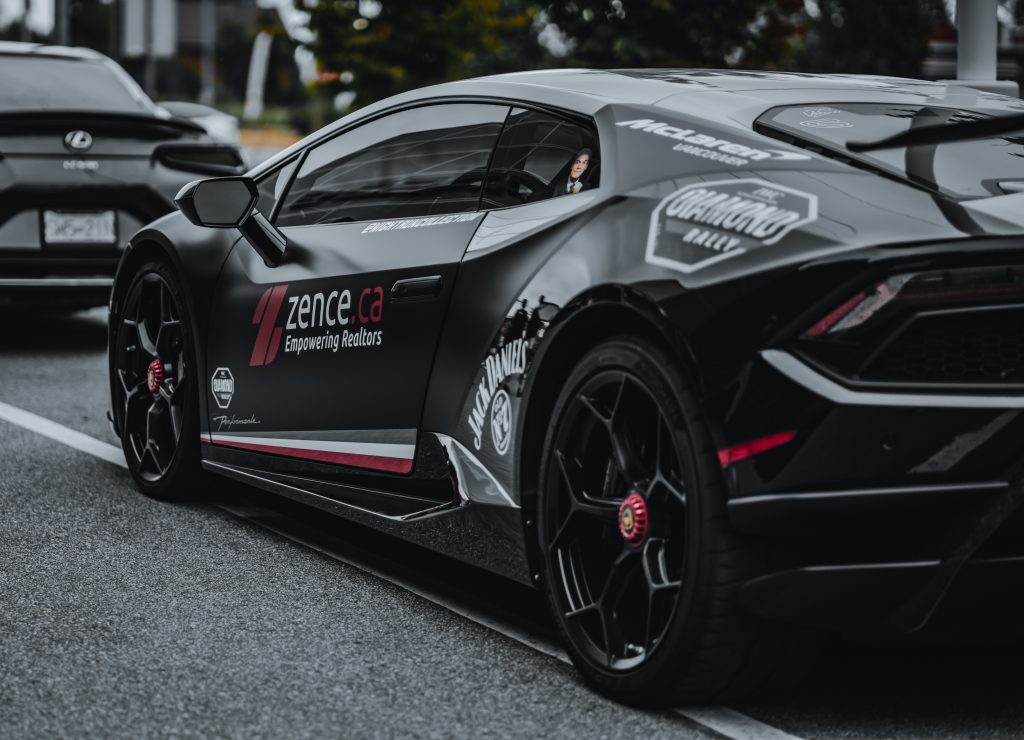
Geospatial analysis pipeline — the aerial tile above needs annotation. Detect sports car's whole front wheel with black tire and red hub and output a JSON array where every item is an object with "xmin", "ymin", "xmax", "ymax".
[{"xmin": 111, "ymin": 259, "xmax": 206, "ymax": 500}]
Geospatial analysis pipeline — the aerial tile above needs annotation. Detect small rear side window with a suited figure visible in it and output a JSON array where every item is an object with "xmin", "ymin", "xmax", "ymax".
[{"xmin": 482, "ymin": 108, "xmax": 601, "ymax": 208}]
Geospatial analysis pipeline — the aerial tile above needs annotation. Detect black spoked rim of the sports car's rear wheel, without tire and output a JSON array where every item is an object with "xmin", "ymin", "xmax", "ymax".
[{"xmin": 545, "ymin": 368, "xmax": 686, "ymax": 671}]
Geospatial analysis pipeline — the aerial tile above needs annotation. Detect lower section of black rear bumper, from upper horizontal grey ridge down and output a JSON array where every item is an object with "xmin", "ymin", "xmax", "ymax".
[{"xmin": 729, "ymin": 479, "xmax": 1024, "ymax": 637}]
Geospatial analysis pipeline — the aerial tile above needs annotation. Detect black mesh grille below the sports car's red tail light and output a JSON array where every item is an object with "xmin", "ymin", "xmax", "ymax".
[{"xmin": 860, "ymin": 307, "xmax": 1024, "ymax": 384}]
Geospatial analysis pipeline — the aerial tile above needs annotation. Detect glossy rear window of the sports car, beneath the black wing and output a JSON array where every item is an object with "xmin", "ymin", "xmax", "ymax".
[{"xmin": 758, "ymin": 103, "xmax": 1024, "ymax": 199}]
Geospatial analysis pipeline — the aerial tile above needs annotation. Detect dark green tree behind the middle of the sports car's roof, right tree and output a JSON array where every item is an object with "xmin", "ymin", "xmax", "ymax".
[{"xmin": 545, "ymin": 0, "xmax": 806, "ymax": 69}]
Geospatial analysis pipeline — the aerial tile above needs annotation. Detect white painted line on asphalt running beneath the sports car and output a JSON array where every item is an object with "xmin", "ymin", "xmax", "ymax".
[{"xmin": 0, "ymin": 401, "xmax": 801, "ymax": 740}]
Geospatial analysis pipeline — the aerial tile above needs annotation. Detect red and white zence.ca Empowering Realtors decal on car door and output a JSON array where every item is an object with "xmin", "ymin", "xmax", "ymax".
[{"xmin": 250, "ymin": 285, "xmax": 384, "ymax": 368}]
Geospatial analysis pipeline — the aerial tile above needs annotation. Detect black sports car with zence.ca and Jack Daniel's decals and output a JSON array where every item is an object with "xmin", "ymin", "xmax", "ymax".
[{"xmin": 110, "ymin": 70, "xmax": 1024, "ymax": 703}]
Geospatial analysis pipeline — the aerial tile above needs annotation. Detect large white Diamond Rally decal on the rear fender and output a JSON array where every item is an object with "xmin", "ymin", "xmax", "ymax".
[{"xmin": 646, "ymin": 179, "xmax": 818, "ymax": 272}]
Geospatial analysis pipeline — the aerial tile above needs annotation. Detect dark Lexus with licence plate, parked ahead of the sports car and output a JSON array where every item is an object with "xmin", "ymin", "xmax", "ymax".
[{"xmin": 0, "ymin": 42, "xmax": 245, "ymax": 308}]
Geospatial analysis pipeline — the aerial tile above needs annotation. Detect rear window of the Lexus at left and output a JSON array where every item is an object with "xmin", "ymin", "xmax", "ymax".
[{"xmin": 0, "ymin": 55, "xmax": 154, "ymax": 114}]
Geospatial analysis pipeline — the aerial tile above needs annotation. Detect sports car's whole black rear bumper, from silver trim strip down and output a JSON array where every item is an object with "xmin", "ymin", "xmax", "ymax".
[{"xmin": 726, "ymin": 351, "xmax": 1024, "ymax": 638}]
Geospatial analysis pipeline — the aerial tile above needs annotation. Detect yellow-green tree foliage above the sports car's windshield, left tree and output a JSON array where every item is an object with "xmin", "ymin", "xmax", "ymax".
[{"xmin": 297, "ymin": 0, "xmax": 532, "ymax": 105}]
